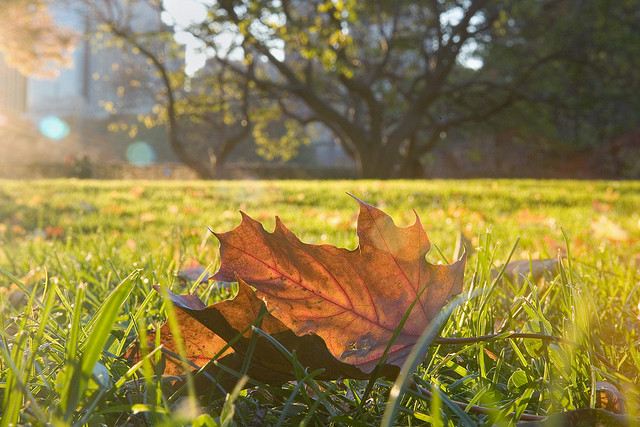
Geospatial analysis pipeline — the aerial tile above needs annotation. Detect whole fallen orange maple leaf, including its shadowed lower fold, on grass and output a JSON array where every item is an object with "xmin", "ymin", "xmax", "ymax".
[{"xmin": 129, "ymin": 199, "xmax": 465, "ymax": 390}]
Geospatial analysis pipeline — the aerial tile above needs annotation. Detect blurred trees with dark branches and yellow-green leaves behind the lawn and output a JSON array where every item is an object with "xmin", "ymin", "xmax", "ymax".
[{"xmin": 6, "ymin": 0, "xmax": 640, "ymax": 178}]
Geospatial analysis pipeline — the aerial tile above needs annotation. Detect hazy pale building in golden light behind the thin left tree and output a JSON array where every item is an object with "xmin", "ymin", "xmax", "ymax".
[{"xmin": 0, "ymin": 0, "xmax": 183, "ymax": 176}]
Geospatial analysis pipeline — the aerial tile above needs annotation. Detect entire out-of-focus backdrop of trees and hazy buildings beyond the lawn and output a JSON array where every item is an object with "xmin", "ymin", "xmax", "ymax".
[{"xmin": 0, "ymin": 0, "xmax": 640, "ymax": 179}]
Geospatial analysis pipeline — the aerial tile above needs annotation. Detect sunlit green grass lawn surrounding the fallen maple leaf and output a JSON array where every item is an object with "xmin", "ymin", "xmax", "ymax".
[{"xmin": 0, "ymin": 180, "xmax": 640, "ymax": 425}]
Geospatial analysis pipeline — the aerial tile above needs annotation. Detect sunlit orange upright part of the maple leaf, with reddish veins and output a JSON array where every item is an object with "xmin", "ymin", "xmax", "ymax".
[{"xmin": 213, "ymin": 199, "xmax": 466, "ymax": 374}]
